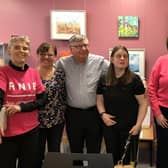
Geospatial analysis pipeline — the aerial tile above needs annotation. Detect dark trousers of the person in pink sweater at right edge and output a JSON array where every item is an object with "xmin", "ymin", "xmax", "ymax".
[{"xmin": 155, "ymin": 107, "xmax": 168, "ymax": 168}]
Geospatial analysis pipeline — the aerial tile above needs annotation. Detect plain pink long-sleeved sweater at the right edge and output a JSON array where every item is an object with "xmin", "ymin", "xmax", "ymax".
[{"xmin": 148, "ymin": 55, "xmax": 168, "ymax": 116}]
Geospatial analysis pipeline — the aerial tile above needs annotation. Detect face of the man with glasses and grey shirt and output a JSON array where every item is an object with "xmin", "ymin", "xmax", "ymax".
[{"xmin": 70, "ymin": 39, "xmax": 89, "ymax": 63}]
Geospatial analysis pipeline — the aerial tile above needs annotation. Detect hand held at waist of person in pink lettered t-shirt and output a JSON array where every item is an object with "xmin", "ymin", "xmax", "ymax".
[{"xmin": 5, "ymin": 104, "xmax": 21, "ymax": 116}]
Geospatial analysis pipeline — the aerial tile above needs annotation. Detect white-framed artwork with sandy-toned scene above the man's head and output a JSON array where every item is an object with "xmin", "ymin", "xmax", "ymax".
[{"xmin": 50, "ymin": 10, "xmax": 86, "ymax": 40}]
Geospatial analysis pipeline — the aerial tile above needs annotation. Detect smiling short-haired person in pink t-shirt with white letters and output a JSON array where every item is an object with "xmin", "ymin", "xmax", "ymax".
[{"xmin": 0, "ymin": 36, "xmax": 47, "ymax": 168}]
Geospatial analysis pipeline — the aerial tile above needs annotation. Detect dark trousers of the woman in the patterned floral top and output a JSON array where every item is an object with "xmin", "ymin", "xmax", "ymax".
[{"xmin": 39, "ymin": 123, "xmax": 64, "ymax": 167}]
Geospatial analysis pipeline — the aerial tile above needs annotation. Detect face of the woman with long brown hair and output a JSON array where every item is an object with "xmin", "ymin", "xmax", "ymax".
[{"xmin": 111, "ymin": 49, "xmax": 129, "ymax": 70}]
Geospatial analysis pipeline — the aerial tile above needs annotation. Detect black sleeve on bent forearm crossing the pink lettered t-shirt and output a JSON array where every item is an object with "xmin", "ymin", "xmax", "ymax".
[{"xmin": 20, "ymin": 92, "xmax": 47, "ymax": 112}]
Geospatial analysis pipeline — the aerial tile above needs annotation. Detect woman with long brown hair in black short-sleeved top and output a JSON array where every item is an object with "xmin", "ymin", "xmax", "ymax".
[{"xmin": 97, "ymin": 45, "xmax": 147, "ymax": 164}]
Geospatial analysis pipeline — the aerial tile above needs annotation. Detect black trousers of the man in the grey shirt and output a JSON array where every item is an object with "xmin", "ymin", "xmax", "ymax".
[{"xmin": 65, "ymin": 107, "xmax": 102, "ymax": 153}]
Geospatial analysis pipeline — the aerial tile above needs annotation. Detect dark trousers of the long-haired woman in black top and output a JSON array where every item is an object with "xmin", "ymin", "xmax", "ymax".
[{"xmin": 103, "ymin": 125, "xmax": 139, "ymax": 164}]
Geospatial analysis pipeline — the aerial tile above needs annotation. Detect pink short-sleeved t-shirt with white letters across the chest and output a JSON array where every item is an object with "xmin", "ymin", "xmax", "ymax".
[{"xmin": 0, "ymin": 65, "xmax": 45, "ymax": 137}]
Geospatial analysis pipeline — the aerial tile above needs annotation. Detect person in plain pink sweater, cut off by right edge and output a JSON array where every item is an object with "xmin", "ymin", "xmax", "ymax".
[{"xmin": 148, "ymin": 38, "xmax": 168, "ymax": 168}]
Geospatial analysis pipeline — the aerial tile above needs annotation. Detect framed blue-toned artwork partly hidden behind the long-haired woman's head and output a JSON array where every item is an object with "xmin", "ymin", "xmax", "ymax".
[{"xmin": 109, "ymin": 48, "xmax": 145, "ymax": 77}]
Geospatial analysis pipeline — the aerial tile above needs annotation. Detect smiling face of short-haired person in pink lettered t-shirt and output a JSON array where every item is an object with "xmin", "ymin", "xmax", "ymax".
[{"xmin": 8, "ymin": 41, "xmax": 30, "ymax": 68}]
